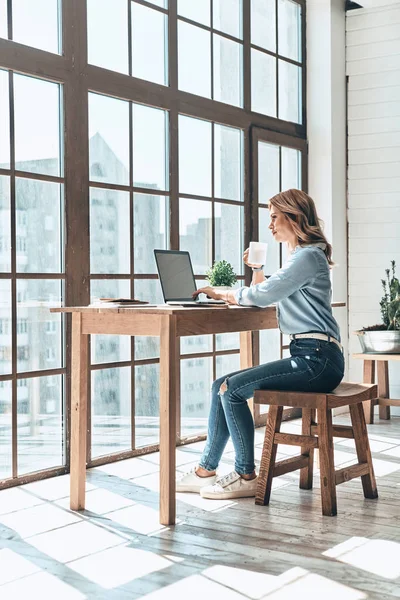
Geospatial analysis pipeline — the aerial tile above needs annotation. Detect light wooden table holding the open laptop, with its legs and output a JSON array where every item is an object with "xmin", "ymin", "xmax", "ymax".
[{"xmin": 51, "ymin": 303, "xmax": 344, "ymax": 525}]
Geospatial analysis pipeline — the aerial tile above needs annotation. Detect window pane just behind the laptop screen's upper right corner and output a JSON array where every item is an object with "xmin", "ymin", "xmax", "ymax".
[{"xmin": 179, "ymin": 198, "xmax": 212, "ymax": 275}]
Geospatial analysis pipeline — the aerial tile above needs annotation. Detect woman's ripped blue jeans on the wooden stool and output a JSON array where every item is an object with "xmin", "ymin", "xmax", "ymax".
[{"xmin": 199, "ymin": 338, "xmax": 344, "ymax": 475}]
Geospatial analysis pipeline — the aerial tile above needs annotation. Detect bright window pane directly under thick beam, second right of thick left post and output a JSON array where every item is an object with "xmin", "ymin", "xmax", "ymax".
[{"xmin": 133, "ymin": 104, "xmax": 169, "ymax": 190}]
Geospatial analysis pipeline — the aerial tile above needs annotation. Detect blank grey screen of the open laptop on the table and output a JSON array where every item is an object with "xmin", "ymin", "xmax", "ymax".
[{"xmin": 155, "ymin": 250, "xmax": 196, "ymax": 302}]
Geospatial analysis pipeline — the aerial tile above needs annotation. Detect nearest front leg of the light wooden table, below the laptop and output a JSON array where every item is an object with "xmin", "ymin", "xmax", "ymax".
[{"xmin": 160, "ymin": 315, "xmax": 180, "ymax": 525}]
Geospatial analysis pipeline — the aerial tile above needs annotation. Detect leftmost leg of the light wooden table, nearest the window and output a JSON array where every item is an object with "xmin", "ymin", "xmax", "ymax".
[{"xmin": 70, "ymin": 313, "xmax": 88, "ymax": 510}]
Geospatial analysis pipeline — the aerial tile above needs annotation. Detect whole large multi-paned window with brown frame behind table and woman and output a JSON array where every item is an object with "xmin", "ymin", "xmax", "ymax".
[{"xmin": 0, "ymin": 0, "xmax": 306, "ymax": 485}]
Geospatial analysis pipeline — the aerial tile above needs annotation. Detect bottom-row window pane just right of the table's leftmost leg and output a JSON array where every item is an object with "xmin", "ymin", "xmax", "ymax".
[{"xmin": 91, "ymin": 367, "xmax": 132, "ymax": 458}]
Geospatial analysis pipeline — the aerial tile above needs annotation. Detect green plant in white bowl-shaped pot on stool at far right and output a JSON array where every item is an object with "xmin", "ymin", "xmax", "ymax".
[{"xmin": 355, "ymin": 260, "xmax": 400, "ymax": 354}]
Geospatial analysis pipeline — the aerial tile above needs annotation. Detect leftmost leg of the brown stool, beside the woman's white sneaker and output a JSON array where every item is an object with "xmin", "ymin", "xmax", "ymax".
[{"xmin": 256, "ymin": 405, "xmax": 283, "ymax": 506}]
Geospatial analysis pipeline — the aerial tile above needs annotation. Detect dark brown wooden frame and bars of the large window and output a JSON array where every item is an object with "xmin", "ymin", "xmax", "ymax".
[{"xmin": 0, "ymin": 0, "xmax": 307, "ymax": 488}]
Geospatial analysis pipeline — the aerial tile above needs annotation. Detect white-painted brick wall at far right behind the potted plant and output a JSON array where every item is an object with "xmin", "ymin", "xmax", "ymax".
[{"xmin": 346, "ymin": 0, "xmax": 400, "ymax": 412}]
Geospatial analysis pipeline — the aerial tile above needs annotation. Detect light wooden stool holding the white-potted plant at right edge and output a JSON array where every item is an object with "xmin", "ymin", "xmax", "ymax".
[{"xmin": 353, "ymin": 354, "xmax": 400, "ymax": 423}]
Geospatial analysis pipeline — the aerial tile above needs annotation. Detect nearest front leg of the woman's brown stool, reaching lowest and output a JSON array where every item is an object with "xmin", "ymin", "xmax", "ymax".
[{"xmin": 317, "ymin": 408, "xmax": 337, "ymax": 517}]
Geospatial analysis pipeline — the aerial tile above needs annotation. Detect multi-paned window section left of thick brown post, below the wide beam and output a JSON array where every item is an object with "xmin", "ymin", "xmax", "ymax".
[{"xmin": 0, "ymin": 70, "xmax": 66, "ymax": 479}]
